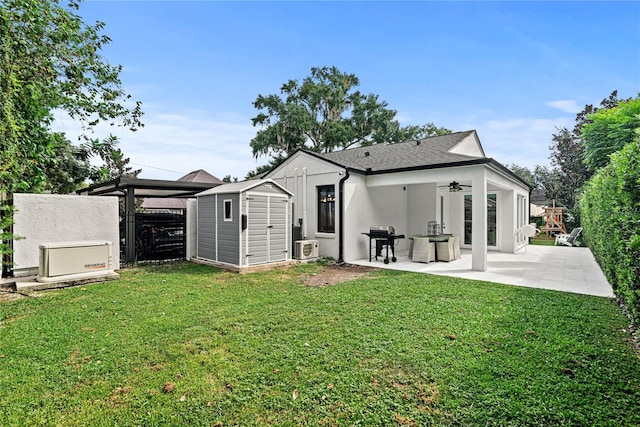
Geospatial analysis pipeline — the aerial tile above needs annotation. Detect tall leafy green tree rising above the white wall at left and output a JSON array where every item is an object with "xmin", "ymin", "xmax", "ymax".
[{"xmin": 0, "ymin": 0, "xmax": 142, "ymax": 195}]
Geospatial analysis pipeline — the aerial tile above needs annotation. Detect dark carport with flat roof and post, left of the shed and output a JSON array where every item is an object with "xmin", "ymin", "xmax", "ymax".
[{"xmin": 76, "ymin": 177, "xmax": 220, "ymax": 263}]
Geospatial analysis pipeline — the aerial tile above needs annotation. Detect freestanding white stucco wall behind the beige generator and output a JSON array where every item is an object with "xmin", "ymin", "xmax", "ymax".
[{"xmin": 13, "ymin": 194, "xmax": 120, "ymax": 276}]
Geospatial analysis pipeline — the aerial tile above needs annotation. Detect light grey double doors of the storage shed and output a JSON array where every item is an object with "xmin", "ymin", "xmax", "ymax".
[{"xmin": 246, "ymin": 194, "xmax": 289, "ymax": 265}]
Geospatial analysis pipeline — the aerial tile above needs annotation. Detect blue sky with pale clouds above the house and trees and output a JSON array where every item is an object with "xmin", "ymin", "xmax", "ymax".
[{"xmin": 55, "ymin": 0, "xmax": 640, "ymax": 180}]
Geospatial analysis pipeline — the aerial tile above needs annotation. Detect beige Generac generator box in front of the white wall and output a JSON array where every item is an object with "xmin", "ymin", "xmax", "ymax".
[{"xmin": 36, "ymin": 240, "xmax": 115, "ymax": 283}]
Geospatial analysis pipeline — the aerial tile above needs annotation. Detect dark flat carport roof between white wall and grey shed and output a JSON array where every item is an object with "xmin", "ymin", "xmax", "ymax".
[{"xmin": 76, "ymin": 177, "xmax": 220, "ymax": 198}]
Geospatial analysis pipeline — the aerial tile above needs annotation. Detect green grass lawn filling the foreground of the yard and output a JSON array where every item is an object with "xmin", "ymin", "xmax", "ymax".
[{"xmin": 0, "ymin": 263, "xmax": 640, "ymax": 426}]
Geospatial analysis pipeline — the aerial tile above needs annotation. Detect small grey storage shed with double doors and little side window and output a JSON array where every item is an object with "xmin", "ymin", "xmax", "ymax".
[{"xmin": 195, "ymin": 179, "xmax": 293, "ymax": 269}]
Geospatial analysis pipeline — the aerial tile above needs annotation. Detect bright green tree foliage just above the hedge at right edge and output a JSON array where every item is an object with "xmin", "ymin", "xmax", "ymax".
[{"xmin": 581, "ymin": 97, "xmax": 640, "ymax": 172}]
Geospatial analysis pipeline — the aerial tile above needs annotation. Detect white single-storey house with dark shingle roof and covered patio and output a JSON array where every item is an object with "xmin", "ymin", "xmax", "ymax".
[{"xmin": 266, "ymin": 130, "xmax": 530, "ymax": 271}]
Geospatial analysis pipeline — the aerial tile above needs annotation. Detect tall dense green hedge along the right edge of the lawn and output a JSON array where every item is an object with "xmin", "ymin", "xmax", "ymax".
[{"xmin": 580, "ymin": 138, "xmax": 640, "ymax": 324}]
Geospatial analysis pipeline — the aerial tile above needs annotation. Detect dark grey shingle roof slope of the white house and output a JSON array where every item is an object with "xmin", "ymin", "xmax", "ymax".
[{"xmin": 318, "ymin": 130, "xmax": 486, "ymax": 173}]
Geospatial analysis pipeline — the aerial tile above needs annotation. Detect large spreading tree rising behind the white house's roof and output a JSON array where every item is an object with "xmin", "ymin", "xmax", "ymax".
[{"xmin": 251, "ymin": 67, "xmax": 451, "ymax": 163}]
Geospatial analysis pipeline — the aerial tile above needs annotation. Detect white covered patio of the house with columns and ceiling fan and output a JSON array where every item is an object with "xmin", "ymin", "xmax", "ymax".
[{"xmin": 345, "ymin": 163, "xmax": 529, "ymax": 271}]
